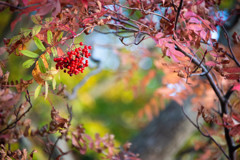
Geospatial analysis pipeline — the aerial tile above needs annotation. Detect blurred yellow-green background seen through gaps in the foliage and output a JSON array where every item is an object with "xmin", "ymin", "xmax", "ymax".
[{"xmin": 0, "ymin": 9, "xmax": 162, "ymax": 159}]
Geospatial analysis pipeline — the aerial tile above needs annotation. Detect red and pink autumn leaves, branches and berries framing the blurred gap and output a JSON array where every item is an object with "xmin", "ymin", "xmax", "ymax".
[{"xmin": 0, "ymin": 0, "xmax": 240, "ymax": 160}]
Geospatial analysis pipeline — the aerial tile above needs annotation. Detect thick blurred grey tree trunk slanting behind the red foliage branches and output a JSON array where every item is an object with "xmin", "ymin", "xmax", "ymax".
[{"xmin": 131, "ymin": 101, "xmax": 196, "ymax": 160}]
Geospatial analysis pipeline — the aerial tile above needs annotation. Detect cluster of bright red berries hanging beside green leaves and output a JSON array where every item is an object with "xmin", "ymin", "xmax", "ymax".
[{"xmin": 54, "ymin": 42, "xmax": 92, "ymax": 76}]
